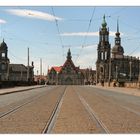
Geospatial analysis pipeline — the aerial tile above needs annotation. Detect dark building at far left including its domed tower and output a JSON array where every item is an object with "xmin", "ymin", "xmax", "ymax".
[{"xmin": 0, "ymin": 40, "xmax": 34, "ymax": 85}]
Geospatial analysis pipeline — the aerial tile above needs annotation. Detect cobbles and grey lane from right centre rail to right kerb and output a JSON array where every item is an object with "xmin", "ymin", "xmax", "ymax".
[{"xmin": 77, "ymin": 87, "xmax": 140, "ymax": 133}]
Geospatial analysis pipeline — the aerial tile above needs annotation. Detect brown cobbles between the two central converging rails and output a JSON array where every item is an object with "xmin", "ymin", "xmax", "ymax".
[{"xmin": 52, "ymin": 87, "xmax": 104, "ymax": 133}]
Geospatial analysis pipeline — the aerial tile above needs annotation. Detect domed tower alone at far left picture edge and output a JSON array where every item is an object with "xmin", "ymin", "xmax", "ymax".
[{"xmin": 0, "ymin": 39, "xmax": 9, "ymax": 81}]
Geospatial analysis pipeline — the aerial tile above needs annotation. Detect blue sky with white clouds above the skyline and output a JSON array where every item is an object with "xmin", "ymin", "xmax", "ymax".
[{"xmin": 0, "ymin": 6, "xmax": 140, "ymax": 74}]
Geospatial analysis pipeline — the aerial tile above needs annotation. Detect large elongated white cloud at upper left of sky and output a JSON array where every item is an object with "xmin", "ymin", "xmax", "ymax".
[{"xmin": 6, "ymin": 9, "xmax": 62, "ymax": 21}]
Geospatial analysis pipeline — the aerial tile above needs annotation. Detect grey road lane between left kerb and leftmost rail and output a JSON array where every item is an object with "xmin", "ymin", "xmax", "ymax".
[{"xmin": 0, "ymin": 86, "xmax": 54, "ymax": 115}]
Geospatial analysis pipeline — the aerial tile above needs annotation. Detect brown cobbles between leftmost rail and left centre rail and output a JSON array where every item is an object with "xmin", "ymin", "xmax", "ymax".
[{"xmin": 0, "ymin": 87, "xmax": 64, "ymax": 133}]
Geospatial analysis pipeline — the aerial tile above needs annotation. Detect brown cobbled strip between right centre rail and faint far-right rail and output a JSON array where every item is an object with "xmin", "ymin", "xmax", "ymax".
[{"xmin": 78, "ymin": 88, "xmax": 140, "ymax": 133}]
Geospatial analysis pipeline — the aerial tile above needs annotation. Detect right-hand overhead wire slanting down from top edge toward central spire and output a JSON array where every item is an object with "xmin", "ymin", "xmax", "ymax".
[{"xmin": 76, "ymin": 7, "xmax": 96, "ymax": 61}]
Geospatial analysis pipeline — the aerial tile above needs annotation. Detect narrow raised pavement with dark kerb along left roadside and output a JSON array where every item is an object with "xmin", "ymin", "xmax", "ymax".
[{"xmin": 0, "ymin": 85, "xmax": 46, "ymax": 95}]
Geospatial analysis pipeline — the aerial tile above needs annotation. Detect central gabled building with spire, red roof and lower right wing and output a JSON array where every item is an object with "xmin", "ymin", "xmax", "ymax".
[{"xmin": 47, "ymin": 49, "xmax": 96, "ymax": 85}]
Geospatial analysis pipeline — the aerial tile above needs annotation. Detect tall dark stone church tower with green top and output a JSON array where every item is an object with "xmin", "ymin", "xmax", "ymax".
[{"xmin": 96, "ymin": 15, "xmax": 110, "ymax": 83}]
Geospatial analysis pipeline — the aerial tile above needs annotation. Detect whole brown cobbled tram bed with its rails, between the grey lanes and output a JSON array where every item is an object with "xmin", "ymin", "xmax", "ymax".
[{"xmin": 0, "ymin": 86, "xmax": 140, "ymax": 134}]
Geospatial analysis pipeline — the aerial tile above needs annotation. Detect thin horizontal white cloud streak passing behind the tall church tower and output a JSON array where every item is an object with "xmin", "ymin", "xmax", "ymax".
[{"xmin": 60, "ymin": 31, "xmax": 123, "ymax": 37}]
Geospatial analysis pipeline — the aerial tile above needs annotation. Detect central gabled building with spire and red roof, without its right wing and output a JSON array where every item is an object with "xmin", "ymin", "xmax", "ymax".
[{"xmin": 48, "ymin": 49, "xmax": 84, "ymax": 85}]
